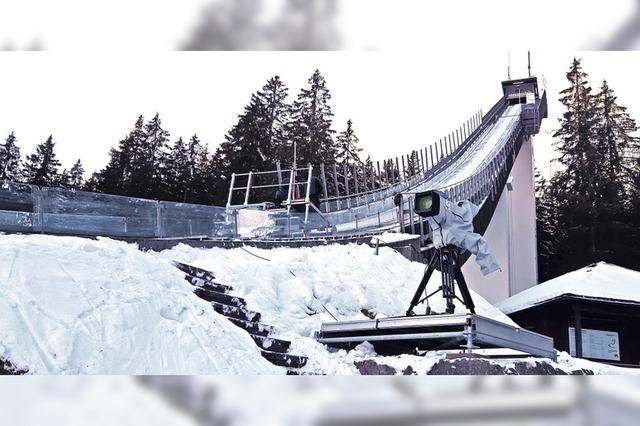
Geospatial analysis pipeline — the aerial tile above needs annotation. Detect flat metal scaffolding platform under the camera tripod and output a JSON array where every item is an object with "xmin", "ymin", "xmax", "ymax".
[{"xmin": 316, "ymin": 313, "xmax": 556, "ymax": 361}]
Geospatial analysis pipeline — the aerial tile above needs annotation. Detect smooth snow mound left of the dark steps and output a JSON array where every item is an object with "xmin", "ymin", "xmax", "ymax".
[{"xmin": 0, "ymin": 235, "xmax": 283, "ymax": 374}]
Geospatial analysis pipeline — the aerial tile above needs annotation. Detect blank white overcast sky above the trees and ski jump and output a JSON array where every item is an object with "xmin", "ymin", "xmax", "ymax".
[{"xmin": 0, "ymin": 50, "xmax": 640, "ymax": 179}]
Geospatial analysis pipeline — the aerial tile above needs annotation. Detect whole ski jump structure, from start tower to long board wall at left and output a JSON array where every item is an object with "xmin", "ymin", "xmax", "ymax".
[{"xmin": 0, "ymin": 77, "xmax": 547, "ymax": 302}]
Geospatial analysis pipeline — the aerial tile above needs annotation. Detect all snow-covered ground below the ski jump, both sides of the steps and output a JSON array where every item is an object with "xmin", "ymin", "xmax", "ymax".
[{"xmin": 0, "ymin": 235, "xmax": 629, "ymax": 375}]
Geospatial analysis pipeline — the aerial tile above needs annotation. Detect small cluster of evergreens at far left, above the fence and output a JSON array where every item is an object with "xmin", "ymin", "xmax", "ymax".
[{"xmin": 0, "ymin": 132, "xmax": 84, "ymax": 189}]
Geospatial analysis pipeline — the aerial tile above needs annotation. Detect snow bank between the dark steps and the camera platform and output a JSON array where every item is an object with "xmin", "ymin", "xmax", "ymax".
[{"xmin": 156, "ymin": 244, "xmax": 516, "ymax": 374}]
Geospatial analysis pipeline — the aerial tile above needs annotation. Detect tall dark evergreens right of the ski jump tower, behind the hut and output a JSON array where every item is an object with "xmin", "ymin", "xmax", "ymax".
[{"xmin": 536, "ymin": 59, "xmax": 640, "ymax": 281}]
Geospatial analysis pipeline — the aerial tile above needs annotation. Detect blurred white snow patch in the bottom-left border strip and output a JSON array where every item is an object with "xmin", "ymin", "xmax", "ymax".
[{"xmin": 0, "ymin": 376, "xmax": 198, "ymax": 426}]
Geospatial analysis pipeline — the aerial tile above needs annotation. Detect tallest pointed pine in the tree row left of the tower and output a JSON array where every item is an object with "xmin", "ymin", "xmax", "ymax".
[{"xmin": 291, "ymin": 70, "xmax": 336, "ymax": 165}]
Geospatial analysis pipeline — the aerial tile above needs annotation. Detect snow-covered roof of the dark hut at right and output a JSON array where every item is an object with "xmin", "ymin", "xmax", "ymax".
[{"xmin": 496, "ymin": 262, "xmax": 640, "ymax": 314}]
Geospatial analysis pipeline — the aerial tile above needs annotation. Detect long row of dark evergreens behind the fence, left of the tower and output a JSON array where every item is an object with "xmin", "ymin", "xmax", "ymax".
[{"xmin": 0, "ymin": 70, "xmax": 372, "ymax": 205}]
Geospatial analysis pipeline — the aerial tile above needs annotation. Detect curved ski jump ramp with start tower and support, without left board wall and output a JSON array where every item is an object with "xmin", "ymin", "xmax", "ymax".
[{"xmin": 228, "ymin": 77, "xmax": 547, "ymax": 303}]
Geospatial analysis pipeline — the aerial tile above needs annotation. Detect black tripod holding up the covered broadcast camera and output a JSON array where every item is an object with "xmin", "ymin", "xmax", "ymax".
[{"xmin": 406, "ymin": 245, "xmax": 476, "ymax": 316}]
